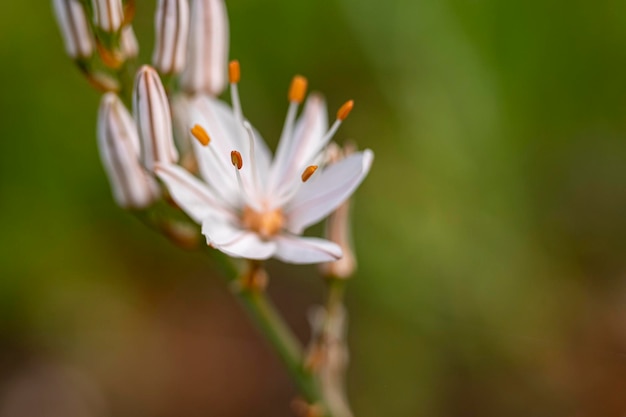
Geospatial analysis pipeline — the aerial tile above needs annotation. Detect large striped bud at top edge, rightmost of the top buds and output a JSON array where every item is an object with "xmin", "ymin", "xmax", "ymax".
[{"xmin": 181, "ymin": 0, "xmax": 229, "ymax": 96}]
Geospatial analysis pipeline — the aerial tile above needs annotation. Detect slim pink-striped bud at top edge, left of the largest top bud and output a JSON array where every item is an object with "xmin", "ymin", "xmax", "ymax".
[{"xmin": 152, "ymin": 0, "xmax": 189, "ymax": 74}]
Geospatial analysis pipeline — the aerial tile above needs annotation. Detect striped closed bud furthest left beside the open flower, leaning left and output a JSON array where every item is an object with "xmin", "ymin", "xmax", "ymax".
[{"xmin": 98, "ymin": 93, "xmax": 159, "ymax": 209}]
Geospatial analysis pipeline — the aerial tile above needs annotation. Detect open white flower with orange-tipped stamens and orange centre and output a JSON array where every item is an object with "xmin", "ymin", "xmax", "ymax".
[{"xmin": 155, "ymin": 63, "xmax": 373, "ymax": 263}]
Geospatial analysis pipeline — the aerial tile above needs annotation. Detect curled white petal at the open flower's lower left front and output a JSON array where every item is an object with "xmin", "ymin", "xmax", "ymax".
[{"xmin": 202, "ymin": 217, "xmax": 276, "ymax": 259}]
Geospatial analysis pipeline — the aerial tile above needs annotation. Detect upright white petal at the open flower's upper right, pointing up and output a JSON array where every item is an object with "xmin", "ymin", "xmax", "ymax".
[{"xmin": 271, "ymin": 94, "xmax": 328, "ymax": 194}]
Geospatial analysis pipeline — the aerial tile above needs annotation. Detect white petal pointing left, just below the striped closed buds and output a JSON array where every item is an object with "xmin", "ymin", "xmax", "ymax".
[{"xmin": 155, "ymin": 164, "xmax": 234, "ymax": 223}]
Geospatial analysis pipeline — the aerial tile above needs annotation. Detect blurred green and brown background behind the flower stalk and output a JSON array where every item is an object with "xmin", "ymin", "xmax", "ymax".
[{"xmin": 0, "ymin": 0, "xmax": 626, "ymax": 417}]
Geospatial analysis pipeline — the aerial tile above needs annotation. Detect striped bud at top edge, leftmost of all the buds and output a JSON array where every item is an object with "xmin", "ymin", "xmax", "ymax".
[{"xmin": 52, "ymin": 0, "xmax": 94, "ymax": 59}]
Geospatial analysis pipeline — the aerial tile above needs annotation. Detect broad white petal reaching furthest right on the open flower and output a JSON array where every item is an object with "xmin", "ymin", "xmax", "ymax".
[{"xmin": 285, "ymin": 149, "xmax": 374, "ymax": 234}]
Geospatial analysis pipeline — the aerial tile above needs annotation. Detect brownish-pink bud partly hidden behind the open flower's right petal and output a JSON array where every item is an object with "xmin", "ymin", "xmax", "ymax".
[{"xmin": 320, "ymin": 143, "xmax": 356, "ymax": 279}]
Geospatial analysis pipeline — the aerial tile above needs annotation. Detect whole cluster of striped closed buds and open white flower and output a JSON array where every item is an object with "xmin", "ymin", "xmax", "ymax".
[{"xmin": 53, "ymin": 0, "xmax": 373, "ymax": 264}]
